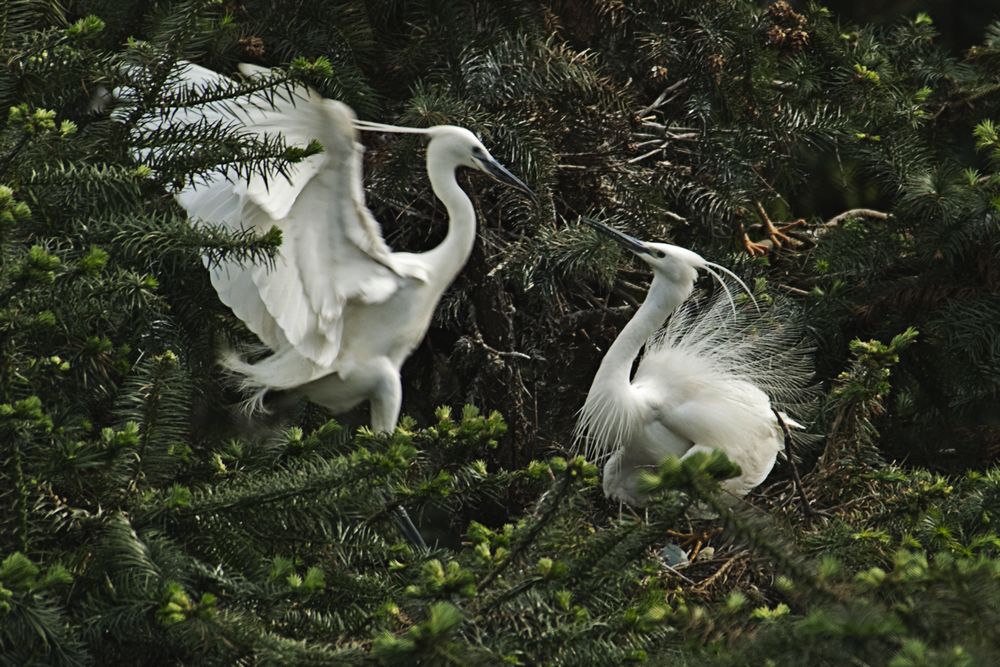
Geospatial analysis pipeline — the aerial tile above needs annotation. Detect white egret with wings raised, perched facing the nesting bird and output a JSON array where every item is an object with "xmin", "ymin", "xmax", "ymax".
[{"xmin": 124, "ymin": 63, "xmax": 530, "ymax": 431}]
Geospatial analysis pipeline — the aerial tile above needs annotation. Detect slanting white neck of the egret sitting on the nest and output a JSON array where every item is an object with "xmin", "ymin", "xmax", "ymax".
[{"xmin": 593, "ymin": 274, "xmax": 694, "ymax": 388}]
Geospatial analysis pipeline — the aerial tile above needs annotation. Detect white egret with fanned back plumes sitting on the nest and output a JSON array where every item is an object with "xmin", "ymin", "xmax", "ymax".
[{"xmin": 577, "ymin": 218, "xmax": 811, "ymax": 506}]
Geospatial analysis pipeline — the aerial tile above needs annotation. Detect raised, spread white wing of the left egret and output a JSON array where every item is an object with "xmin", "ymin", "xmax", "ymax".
[{"xmin": 133, "ymin": 63, "xmax": 424, "ymax": 367}]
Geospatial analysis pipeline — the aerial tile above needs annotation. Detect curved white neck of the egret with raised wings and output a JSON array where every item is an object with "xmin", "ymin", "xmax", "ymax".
[{"xmin": 424, "ymin": 148, "xmax": 476, "ymax": 285}]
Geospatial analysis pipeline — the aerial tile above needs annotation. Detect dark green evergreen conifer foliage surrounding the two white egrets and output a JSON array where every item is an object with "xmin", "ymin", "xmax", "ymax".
[{"xmin": 0, "ymin": 0, "xmax": 1000, "ymax": 667}]
